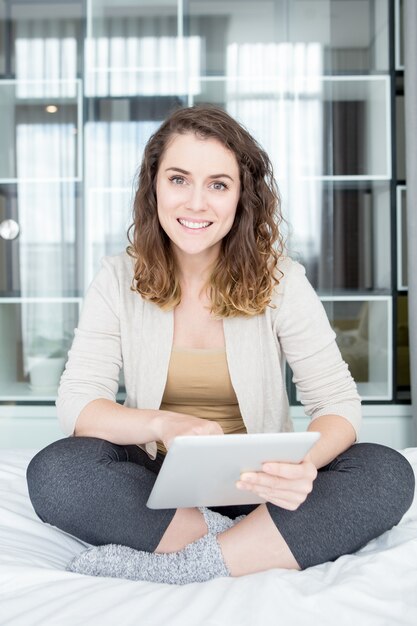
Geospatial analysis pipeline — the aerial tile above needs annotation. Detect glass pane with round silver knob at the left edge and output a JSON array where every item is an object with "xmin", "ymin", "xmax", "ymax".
[{"xmin": 0, "ymin": 182, "xmax": 82, "ymax": 297}]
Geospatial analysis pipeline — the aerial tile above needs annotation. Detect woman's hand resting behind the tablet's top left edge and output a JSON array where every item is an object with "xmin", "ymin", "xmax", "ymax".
[{"xmin": 156, "ymin": 411, "xmax": 224, "ymax": 450}]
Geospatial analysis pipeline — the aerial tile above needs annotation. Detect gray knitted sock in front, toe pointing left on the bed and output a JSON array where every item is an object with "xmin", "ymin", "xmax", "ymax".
[{"xmin": 66, "ymin": 534, "xmax": 230, "ymax": 585}]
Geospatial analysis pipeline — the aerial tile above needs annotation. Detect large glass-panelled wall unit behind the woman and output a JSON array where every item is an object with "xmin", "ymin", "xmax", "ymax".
[{"xmin": 0, "ymin": 0, "xmax": 407, "ymax": 412}]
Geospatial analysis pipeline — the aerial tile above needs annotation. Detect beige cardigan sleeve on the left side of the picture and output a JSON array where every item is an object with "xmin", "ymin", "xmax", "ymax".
[{"xmin": 56, "ymin": 258, "xmax": 122, "ymax": 435}]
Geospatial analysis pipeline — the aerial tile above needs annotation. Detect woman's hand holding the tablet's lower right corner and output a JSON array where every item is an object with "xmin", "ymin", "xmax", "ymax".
[{"xmin": 237, "ymin": 454, "xmax": 317, "ymax": 511}]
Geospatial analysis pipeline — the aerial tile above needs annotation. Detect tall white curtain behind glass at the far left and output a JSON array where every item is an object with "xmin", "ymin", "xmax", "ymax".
[{"xmin": 14, "ymin": 19, "xmax": 80, "ymax": 380}]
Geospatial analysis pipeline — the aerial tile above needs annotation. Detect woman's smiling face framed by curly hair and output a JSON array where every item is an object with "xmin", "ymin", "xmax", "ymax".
[{"xmin": 156, "ymin": 133, "xmax": 240, "ymax": 262}]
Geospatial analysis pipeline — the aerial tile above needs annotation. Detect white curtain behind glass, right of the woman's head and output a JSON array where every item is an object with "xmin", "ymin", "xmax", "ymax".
[{"xmin": 224, "ymin": 43, "xmax": 324, "ymax": 267}]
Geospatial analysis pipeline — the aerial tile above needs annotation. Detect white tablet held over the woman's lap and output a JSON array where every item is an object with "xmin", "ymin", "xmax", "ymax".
[{"xmin": 147, "ymin": 432, "xmax": 320, "ymax": 509}]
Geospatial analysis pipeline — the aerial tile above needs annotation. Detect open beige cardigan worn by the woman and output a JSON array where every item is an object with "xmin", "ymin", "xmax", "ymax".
[{"xmin": 57, "ymin": 253, "xmax": 361, "ymax": 456}]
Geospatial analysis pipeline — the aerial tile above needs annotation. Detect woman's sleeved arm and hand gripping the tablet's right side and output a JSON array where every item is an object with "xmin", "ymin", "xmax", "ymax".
[{"xmin": 238, "ymin": 264, "xmax": 360, "ymax": 510}]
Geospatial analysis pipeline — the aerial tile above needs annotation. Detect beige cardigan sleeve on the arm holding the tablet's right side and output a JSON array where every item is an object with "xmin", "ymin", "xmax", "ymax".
[{"xmin": 274, "ymin": 261, "xmax": 361, "ymax": 436}]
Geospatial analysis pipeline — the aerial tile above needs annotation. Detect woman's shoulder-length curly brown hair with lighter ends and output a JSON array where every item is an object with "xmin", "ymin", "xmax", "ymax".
[{"xmin": 126, "ymin": 105, "xmax": 284, "ymax": 318}]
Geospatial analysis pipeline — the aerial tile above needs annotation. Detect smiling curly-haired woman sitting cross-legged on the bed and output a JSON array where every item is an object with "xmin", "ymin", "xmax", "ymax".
[{"xmin": 28, "ymin": 106, "xmax": 414, "ymax": 584}]
